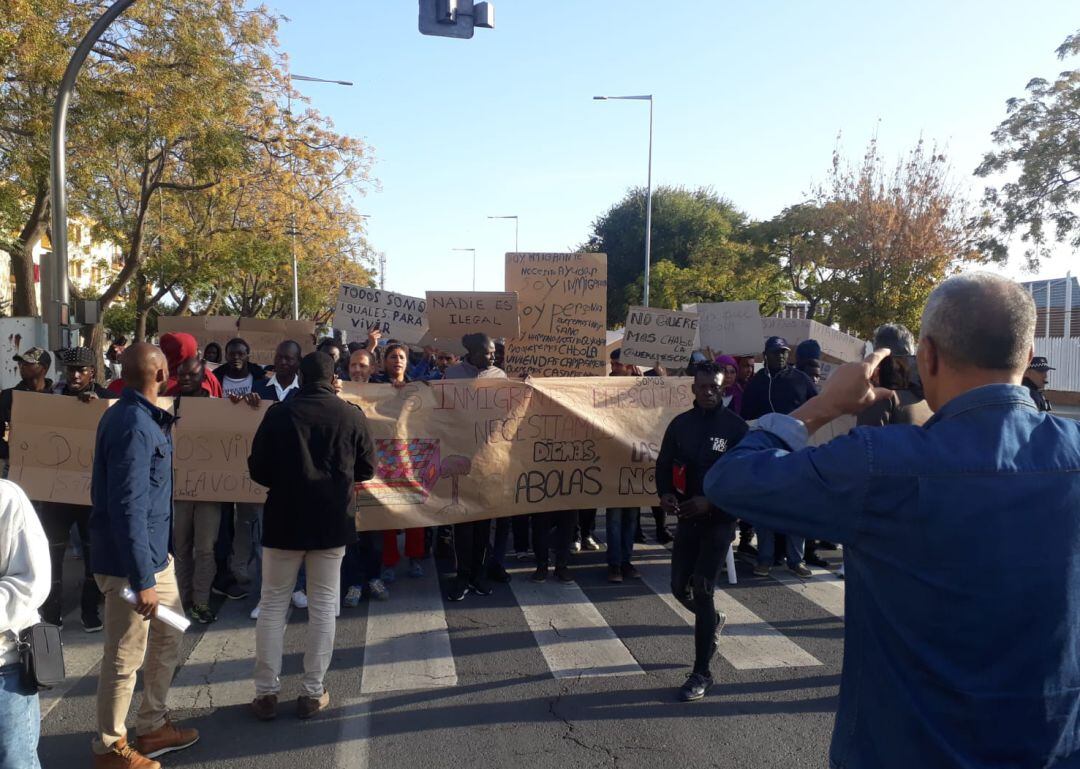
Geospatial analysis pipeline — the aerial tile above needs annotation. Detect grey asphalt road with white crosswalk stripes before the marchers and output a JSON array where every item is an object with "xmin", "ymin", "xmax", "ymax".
[{"xmin": 40, "ymin": 516, "xmax": 843, "ymax": 769}]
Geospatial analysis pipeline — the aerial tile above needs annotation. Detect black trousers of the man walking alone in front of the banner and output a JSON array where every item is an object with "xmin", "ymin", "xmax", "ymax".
[{"xmin": 672, "ymin": 518, "xmax": 735, "ymax": 675}]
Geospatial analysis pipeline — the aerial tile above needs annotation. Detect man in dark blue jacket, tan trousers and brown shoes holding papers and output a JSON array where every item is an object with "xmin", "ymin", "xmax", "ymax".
[{"xmin": 90, "ymin": 343, "xmax": 199, "ymax": 769}]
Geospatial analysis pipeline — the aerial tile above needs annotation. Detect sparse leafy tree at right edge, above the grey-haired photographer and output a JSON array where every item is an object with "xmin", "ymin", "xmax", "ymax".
[{"xmin": 975, "ymin": 32, "xmax": 1080, "ymax": 269}]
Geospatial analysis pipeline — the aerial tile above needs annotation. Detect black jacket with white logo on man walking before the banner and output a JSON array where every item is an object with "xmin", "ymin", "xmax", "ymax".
[{"xmin": 657, "ymin": 404, "xmax": 750, "ymax": 521}]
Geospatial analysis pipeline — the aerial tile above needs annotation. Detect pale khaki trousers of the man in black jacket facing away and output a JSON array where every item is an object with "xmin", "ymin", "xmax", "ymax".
[{"xmin": 255, "ymin": 548, "xmax": 345, "ymax": 697}]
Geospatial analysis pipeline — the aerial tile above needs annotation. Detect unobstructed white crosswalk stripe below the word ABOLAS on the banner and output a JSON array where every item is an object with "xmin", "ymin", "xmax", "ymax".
[{"xmin": 510, "ymin": 570, "xmax": 645, "ymax": 678}]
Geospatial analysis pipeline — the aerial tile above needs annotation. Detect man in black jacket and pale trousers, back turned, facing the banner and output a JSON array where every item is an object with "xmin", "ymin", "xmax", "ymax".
[{"xmin": 247, "ymin": 352, "xmax": 375, "ymax": 720}]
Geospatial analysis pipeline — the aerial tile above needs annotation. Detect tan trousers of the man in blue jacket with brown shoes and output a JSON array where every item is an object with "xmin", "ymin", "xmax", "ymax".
[{"xmin": 94, "ymin": 558, "xmax": 184, "ymax": 753}]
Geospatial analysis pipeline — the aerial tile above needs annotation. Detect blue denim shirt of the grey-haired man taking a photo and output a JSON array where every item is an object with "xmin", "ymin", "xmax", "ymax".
[{"xmin": 705, "ymin": 385, "xmax": 1080, "ymax": 769}]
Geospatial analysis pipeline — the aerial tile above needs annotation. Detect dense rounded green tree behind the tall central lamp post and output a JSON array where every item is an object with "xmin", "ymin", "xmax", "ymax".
[{"xmin": 581, "ymin": 187, "xmax": 781, "ymax": 326}]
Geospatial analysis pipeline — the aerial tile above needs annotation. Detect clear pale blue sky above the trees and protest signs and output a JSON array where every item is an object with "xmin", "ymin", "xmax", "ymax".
[{"xmin": 269, "ymin": 0, "xmax": 1080, "ymax": 296}]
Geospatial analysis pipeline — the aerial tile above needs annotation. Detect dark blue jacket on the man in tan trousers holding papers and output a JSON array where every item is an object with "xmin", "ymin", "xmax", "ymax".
[{"xmin": 90, "ymin": 388, "xmax": 175, "ymax": 592}]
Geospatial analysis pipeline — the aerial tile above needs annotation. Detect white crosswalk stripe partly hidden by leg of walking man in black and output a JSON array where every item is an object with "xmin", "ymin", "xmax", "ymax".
[{"xmin": 636, "ymin": 544, "xmax": 821, "ymax": 671}]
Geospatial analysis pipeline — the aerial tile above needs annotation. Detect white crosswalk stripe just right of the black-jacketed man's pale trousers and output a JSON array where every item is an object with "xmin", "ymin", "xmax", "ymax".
[{"xmin": 361, "ymin": 559, "xmax": 458, "ymax": 694}]
